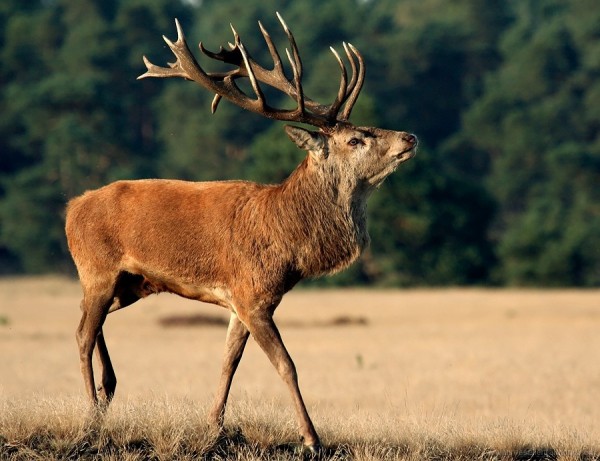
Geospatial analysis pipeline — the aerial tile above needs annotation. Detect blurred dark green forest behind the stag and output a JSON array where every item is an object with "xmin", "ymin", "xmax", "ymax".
[{"xmin": 0, "ymin": 0, "xmax": 600, "ymax": 287}]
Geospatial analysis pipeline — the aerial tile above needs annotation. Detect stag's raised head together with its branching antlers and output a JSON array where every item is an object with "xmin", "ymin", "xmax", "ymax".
[{"xmin": 138, "ymin": 13, "xmax": 417, "ymax": 190}]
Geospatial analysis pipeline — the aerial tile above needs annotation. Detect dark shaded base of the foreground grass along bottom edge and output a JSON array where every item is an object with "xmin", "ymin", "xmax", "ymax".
[{"xmin": 0, "ymin": 429, "xmax": 600, "ymax": 461}]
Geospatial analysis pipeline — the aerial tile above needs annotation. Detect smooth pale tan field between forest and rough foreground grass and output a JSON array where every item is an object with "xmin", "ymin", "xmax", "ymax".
[{"xmin": 0, "ymin": 277, "xmax": 600, "ymax": 456}]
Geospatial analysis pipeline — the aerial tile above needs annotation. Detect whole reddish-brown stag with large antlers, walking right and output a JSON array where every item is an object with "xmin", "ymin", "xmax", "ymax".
[{"xmin": 65, "ymin": 13, "xmax": 418, "ymax": 453}]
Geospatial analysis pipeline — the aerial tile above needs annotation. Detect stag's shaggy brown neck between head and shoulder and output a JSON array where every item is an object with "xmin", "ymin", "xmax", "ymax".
[{"xmin": 272, "ymin": 160, "xmax": 369, "ymax": 277}]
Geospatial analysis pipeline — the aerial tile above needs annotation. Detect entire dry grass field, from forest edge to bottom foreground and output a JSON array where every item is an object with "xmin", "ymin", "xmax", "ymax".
[{"xmin": 0, "ymin": 278, "xmax": 600, "ymax": 460}]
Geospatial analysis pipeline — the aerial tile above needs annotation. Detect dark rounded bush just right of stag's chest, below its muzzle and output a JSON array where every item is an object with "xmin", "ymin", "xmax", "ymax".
[{"xmin": 370, "ymin": 149, "xmax": 495, "ymax": 285}]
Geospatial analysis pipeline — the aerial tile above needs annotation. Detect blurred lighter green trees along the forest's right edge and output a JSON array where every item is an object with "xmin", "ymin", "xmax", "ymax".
[{"xmin": 460, "ymin": 0, "xmax": 600, "ymax": 286}]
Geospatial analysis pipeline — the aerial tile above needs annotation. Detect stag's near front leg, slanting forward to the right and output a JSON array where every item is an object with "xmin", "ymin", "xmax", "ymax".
[{"xmin": 244, "ymin": 311, "xmax": 321, "ymax": 452}]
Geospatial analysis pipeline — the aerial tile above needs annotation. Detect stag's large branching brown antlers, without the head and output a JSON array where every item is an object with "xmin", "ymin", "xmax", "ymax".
[{"xmin": 138, "ymin": 13, "xmax": 365, "ymax": 128}]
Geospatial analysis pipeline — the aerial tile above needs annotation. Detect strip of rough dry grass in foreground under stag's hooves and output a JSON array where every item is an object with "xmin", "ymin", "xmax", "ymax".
[{"xmin": 0, "ymin": 399, "xmax": 600, "ymax": 461}]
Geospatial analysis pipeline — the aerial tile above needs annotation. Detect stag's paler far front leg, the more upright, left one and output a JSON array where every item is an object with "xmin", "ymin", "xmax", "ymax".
[{"xmin": 209, "ymin": 313, "xmax": 249, "ymax": 428}]
